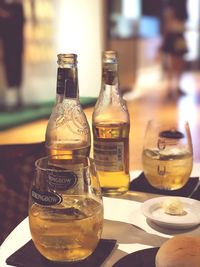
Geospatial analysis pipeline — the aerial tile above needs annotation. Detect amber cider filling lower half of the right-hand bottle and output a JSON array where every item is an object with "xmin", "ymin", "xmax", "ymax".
[{"xmin": 93, "ymin": 122, "xmax": 130, "ymax": 195}]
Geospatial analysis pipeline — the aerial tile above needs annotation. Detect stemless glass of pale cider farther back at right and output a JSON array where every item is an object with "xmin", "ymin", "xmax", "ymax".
[{"xmin": 142, "ymin": 120, "xmax": 193, "ymax": 190}]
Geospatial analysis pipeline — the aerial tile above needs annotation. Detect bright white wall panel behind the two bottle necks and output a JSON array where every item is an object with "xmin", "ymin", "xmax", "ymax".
[{"xmin": 55, "ymin": 0, "xmax": 105, "ymax": 96}]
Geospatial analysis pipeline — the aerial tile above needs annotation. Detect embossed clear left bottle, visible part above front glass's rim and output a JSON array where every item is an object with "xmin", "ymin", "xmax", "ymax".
[{"xmin": 45, "ymin": 54, "xmax": 91, "ymax": 158}]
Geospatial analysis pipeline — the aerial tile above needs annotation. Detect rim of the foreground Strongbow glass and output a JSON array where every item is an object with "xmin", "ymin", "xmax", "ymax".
[{"xmin": 35, "ymin": 154, "xmax": 95, "ymax": 173}]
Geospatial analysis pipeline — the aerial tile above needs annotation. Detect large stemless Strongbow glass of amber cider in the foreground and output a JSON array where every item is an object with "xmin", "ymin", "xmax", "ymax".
[{"xmin": 29, "ymin": 156, "xmax": 103, "ymax": 262}]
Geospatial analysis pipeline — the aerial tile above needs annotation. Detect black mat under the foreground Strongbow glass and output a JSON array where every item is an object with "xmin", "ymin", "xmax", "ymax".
[{"xmin": 6, "ymin": 239, "xmax": 117, "ymax": 267}]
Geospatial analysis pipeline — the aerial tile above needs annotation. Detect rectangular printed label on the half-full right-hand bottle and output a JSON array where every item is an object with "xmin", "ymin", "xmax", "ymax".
[{"xmin": 94, "ymin": 141, "xmax": 124, "ymax": 172}]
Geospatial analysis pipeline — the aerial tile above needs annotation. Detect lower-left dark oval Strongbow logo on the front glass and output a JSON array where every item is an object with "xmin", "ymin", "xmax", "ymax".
[{"xmin": 31, "ymin": 187, "xmax": 62, "ymax": 206}]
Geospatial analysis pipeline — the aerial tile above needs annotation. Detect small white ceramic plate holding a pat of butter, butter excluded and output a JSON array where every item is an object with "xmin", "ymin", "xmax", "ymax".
[{"xmin": 141, "ymin": 196, "xmax": 200, "ymax": 229}]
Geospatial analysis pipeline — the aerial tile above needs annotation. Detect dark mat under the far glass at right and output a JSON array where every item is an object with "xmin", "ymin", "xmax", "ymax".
[{"xmin": 130, "ymin": 172, "xmax": 200, "ymax": 200}]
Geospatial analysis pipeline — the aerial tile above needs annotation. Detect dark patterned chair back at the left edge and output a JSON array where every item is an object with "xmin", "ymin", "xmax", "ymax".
[{"xmin": 0, "ymin": 142, "xmax": 45, "ymax": 244}]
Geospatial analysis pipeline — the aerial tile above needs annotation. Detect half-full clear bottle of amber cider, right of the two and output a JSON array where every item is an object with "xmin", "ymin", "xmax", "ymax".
[{"xmin": 92, "ymin": 51, "xmax": 130, "ymax": 195}]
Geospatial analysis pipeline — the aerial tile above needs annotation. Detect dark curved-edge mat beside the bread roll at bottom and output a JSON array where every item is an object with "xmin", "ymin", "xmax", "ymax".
[{"xmin": 112, "ymin": 247, "xmax": 159, "ymax": 267}]
